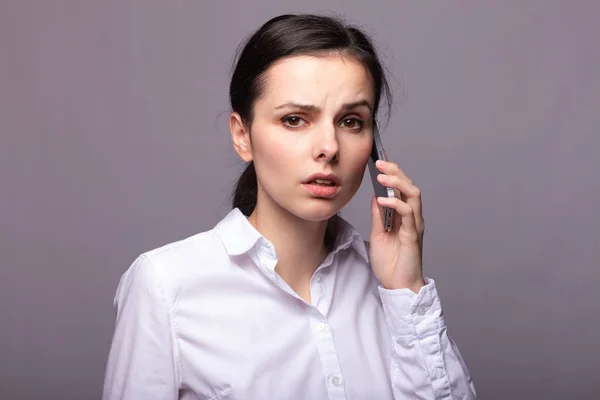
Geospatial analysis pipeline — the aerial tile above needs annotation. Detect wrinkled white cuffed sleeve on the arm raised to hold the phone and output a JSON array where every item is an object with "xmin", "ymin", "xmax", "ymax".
[{"xmin": 378, "ymin": 279, "xmax": 477, "ymax": 400}]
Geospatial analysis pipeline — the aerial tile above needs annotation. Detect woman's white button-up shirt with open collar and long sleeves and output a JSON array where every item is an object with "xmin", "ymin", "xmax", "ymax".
[{"xmin": 103, "ymin": 208, "xmax": 475, "ymax": 400}]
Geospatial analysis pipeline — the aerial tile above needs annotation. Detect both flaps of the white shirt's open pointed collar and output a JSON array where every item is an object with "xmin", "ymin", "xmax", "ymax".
[{"xmin": 215, "ymin": 207, "xmax": 369, "ymax": 263}]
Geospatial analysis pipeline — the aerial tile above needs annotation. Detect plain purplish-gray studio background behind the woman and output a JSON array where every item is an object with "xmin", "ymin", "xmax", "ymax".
[{"xmin": 0, "ymin": 0, "xmax": 600, "ymax": 399}]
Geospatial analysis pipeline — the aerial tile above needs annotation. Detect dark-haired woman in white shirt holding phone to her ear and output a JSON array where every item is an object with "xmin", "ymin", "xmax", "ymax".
[{"xmin": 104, "ymin": 15, "xmax": 475, "ymax": 400}]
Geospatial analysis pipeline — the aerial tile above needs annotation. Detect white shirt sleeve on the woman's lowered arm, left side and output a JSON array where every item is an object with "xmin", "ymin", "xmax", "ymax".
[{"xmin": 102, "ymin": 255, "xmax": 179, "ymax": 400}]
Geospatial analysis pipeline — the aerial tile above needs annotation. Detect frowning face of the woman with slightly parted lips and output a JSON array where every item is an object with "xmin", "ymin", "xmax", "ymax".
[{"xmin": 234, "ymin": 55, "xmax": 374, "ymax": 221}]
